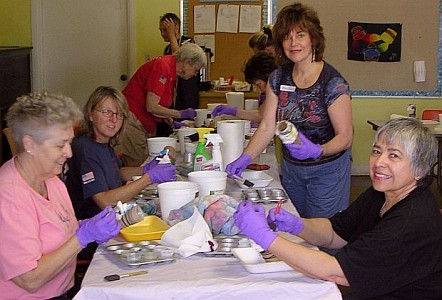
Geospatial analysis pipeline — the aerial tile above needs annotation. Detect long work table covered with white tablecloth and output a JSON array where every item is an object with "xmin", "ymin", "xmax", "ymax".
[{"xmin": 74, "ymin": 153, "xmax": 342, "ymax": 300}]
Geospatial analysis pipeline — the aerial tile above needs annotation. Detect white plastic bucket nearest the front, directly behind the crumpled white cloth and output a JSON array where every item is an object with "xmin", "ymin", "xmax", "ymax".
[{"xmin": 157, "ymin": 181, "xmax": 199, "ymax": 222}]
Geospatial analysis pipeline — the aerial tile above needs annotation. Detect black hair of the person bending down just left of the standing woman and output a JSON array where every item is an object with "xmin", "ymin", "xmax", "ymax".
[{"xmin": 243, "ymin": 51, "xmax": 278, "ymax": 84}]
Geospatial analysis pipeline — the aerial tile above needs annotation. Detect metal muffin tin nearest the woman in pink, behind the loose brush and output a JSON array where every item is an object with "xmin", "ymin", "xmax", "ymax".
[{"xmin": 106, "ymin": 241, "xmax": 176, "ymax": 266}]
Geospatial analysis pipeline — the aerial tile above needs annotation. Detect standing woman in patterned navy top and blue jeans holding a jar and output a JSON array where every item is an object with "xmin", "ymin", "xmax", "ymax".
[{"xmin": 226, "ymin": 3, "xmax": 353, "ymax": 217}]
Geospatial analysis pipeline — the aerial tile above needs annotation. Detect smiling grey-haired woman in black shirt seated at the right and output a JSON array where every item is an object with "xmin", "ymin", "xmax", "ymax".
[{"xmin": 234, "ymin": 118, "xmax": 442, "ymax": 300}]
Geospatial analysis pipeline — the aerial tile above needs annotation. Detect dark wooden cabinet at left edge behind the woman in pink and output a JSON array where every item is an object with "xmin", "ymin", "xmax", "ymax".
[{"xmin": 0, "ymin": 47, "xmax": 32, "ymax": 164}]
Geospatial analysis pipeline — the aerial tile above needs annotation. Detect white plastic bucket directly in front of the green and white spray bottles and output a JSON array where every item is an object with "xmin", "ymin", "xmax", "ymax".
[{"xmin": 187, "ymin": 171, "xmax": 227, "ymax": 197}]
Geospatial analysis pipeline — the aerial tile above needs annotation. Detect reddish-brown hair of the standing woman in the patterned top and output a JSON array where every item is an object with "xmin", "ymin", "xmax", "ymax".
[{"xmin": 273, "ymin": 3, "xmax": 325, "ymax": 65}]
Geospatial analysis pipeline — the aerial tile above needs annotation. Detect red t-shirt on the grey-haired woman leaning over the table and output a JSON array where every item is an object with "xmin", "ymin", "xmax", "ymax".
[{"xmin": 123, "ymin": 55, "xmax": 177, "ymax": 133}]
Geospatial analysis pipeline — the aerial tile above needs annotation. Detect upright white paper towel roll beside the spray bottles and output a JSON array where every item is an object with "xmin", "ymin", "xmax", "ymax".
[{"xmin": 217, "ymin": 120, "xmax": 244, "ymax": 168}]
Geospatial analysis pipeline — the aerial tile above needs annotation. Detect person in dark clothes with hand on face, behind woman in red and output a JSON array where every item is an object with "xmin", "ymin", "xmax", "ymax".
[{"xmin": 157, "ymin": 13, "xmax": 200, "ymax": 136}]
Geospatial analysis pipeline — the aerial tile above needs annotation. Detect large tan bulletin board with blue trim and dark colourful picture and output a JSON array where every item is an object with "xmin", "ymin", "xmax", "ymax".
[{"xmin": 277, "ymin": 0, "xmax": 441, "ymax": 97}]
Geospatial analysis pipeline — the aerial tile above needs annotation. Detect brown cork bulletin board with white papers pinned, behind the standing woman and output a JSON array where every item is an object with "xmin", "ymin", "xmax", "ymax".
[{"xmin": 188, "ymin": 0, "xmax": 263, "ymax": 81}]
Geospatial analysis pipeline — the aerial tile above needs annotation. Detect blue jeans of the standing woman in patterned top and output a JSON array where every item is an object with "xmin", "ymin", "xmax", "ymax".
[{"xmin": 281, "ymin": 150, "xmax": 351, "ymax": 218}]
